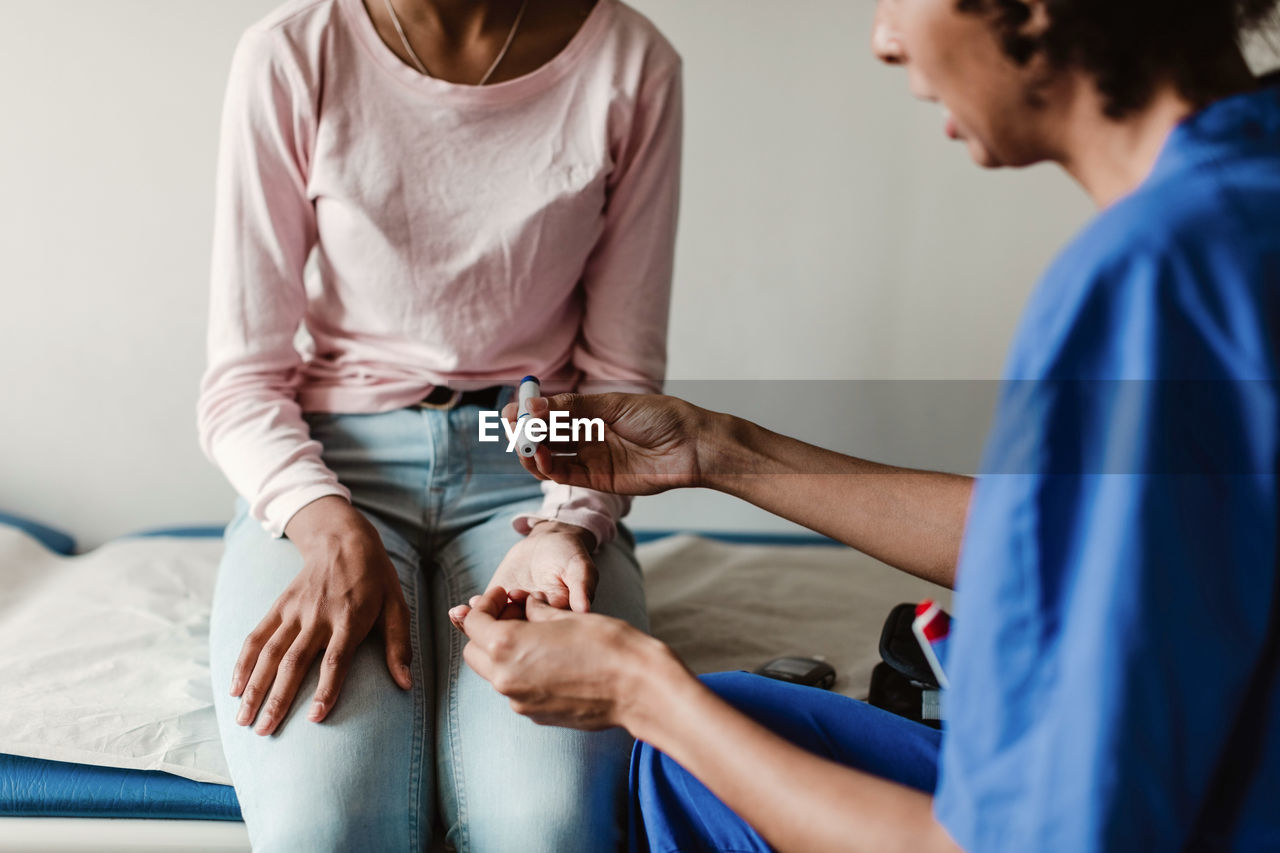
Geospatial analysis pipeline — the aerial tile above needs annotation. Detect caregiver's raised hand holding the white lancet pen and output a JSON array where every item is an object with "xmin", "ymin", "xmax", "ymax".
[{"xmin": 503, "ymin": 393, "xmax": 713, "ymax": 494}]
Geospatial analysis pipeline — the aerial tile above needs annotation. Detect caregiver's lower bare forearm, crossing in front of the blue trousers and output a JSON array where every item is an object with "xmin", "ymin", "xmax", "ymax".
[{"xmin": 627, "ymin": 656, "xmax": 957, "ymax": 853}]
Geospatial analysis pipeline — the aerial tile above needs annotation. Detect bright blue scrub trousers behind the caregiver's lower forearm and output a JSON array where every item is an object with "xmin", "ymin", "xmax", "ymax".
[{"xmin": 631, "ymin": 672, "xmax": 942, "ymax": 853}]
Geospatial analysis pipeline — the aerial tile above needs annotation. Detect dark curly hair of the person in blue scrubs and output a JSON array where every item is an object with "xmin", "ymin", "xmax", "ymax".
[{"xmin": 957, "ymin": 0, "xmax": 1280, "ymax": 118}]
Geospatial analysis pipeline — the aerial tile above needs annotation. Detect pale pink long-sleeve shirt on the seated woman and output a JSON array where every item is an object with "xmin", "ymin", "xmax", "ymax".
[{"xmin": 198, "ymin": 0, "xmax": 681, "ymax": 543}]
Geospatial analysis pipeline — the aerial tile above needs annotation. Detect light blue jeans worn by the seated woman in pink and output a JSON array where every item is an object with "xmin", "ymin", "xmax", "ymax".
[{"xmin": 210, "ymin": 406, "xmax": 646, "ymax": 853}]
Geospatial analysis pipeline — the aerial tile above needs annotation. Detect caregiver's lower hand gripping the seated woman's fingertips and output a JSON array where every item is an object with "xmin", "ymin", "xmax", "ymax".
[{"xmin": 449, "ymin": 587, "xmax": 692, "ymax": 730}]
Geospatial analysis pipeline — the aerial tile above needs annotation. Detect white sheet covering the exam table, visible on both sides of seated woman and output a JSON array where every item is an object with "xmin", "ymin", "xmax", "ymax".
[{"xmin": 0, "ymin": 525, "xmax": 948, "ymax": 784}]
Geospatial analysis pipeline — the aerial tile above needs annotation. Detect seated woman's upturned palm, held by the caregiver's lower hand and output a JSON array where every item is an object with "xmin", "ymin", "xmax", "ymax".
[{"xmin": 489, "ymin": 521, "xmax": 596, "ymax": 613}]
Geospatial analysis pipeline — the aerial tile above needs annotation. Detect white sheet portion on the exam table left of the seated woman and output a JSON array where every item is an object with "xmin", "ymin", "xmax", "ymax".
[{"xmin": 0, "ymin": 526, "xmax": 229, "ymax": 784}]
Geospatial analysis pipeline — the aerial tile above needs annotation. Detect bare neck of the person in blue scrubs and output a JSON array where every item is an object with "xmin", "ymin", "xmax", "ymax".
[{"xmin": 1055, "ymin": 58, "xmax": 1257, "ymax": 207}]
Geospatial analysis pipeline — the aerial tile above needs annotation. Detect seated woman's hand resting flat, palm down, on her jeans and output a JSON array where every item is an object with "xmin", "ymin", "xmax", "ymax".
[{"xmin": 232, "ymin": 497, "xmax": 412, "ymax": 735}]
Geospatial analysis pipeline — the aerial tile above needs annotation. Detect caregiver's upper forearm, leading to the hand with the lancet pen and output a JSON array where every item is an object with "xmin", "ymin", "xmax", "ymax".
[{"xmin": 699, "ymin": 415, "xmax": 973, "ymax": 587}]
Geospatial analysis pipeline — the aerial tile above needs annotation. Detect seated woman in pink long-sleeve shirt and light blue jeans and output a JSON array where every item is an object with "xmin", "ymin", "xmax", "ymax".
[{"xmin": 198, "ymin": 0, "xmax": 681, "ymax": 852}]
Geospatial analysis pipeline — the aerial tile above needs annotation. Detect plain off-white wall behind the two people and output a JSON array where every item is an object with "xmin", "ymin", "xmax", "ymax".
[{"xmin": 0, "ymin": 0, "xmax": 1105, "ymax": 544}]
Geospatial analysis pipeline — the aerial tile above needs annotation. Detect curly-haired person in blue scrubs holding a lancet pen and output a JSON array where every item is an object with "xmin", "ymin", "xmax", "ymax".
[{"xmin": 451, "ymin": 0, "xmax": 1280, "ymax": 853}]
